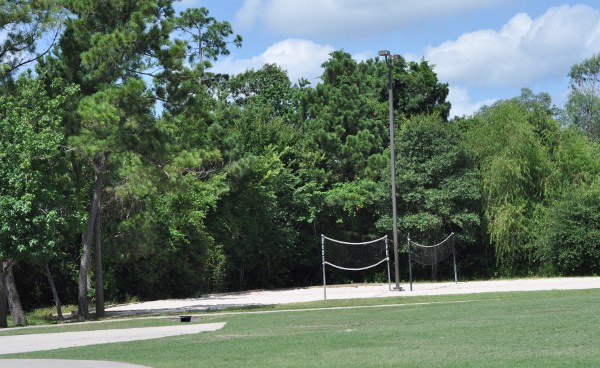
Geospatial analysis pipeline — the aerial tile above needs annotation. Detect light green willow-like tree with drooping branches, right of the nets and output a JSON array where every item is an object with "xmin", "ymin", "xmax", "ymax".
[{"xmin": 469, "ymin": 100, "xmax": 551, "ymax": 272}]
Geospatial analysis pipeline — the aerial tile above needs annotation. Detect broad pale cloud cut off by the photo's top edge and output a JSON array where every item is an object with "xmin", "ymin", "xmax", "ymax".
[{"xmin": 238, "ymin": 0, "xmax": 500, "ymax": 37}]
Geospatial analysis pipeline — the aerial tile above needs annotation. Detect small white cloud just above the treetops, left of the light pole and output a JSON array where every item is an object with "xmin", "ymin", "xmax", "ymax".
[{"xmin": 213, "ymin": 38, "xmax": 335, "ymax": 83}]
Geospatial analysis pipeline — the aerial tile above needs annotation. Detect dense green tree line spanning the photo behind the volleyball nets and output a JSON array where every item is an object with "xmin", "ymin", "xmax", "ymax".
[{"xmin": 0, "ymin": 0, "xmax": 600, "ymax": 326}]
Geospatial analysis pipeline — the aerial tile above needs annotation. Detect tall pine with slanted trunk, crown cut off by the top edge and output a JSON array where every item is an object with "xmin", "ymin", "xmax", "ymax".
[{"xmin": 42, "ymin": 0, "xmax": 173, "ymax": 319}]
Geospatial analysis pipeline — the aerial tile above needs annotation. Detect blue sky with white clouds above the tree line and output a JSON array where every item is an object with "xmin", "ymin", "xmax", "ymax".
[{"xmin": 172, "ymin": 0, "xmax": 600, "ymax": 115}]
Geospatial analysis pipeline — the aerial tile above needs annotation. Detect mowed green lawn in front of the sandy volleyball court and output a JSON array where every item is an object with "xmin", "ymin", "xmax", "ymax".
[{"xmin": 3, "ymin": 290, "xmax": 600, "ymax": 368}]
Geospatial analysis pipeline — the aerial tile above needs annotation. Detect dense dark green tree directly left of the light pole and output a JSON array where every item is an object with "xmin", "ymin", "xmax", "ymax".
[{"xmin": 297, "ymin": 51, "xmax": 389, "ymax": 240}]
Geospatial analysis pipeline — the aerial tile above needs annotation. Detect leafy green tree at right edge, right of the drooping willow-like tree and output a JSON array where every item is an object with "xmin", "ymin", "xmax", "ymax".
[{"xmin": 534, "ymin": 121, "xmax": 600, "ymax": 275}]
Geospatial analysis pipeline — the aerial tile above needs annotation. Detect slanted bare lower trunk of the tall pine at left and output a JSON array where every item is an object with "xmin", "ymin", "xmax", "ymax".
[{"xmin": 77, "ymin": 152, "xmax": 108, "ymax": 320}]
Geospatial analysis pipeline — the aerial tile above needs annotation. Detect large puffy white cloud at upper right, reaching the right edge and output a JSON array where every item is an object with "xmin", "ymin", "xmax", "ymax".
[{"xmin": 425, "ymin": 5, "xmax": 600, "ymax": 87}]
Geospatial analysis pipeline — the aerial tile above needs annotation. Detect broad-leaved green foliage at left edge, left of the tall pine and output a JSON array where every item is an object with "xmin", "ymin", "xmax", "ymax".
[{"xmin": 0, "ymin": 75, "xmax": 76, "ymax": 261}]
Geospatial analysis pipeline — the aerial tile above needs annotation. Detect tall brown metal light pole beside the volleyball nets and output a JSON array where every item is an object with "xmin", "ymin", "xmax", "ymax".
[{"xmin": 379, "ymin": 50, "xmax": 403, "ymax": 291}]
